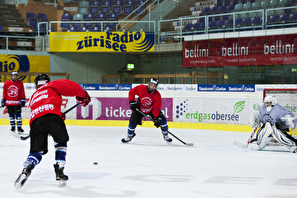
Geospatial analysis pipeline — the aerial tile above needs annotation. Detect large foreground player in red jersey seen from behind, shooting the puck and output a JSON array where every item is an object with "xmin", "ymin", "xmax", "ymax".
[{"xmin": 15, "ymin": 74, "xmax": 91, "ymax": 188}]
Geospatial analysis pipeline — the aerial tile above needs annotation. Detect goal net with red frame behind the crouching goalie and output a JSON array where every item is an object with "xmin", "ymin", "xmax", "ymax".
[{"xmin": 263, "ymin": 89, "xmax": 297, "ymax": 141}]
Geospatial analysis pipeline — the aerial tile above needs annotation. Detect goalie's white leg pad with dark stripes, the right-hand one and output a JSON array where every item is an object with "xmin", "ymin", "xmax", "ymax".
[{"xmin": 272, "ymin": 125, "xmax": 297, "ymax": 150}]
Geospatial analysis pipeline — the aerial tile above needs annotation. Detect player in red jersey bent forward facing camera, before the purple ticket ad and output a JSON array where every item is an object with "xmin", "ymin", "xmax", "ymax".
[{"xmin": 122, "ymin": 78, "xmax": 172, "ymax": 143}]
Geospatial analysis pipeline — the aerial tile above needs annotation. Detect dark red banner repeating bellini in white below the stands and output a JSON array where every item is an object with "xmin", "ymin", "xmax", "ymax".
[{"xmin": 183, "ymin": 34, "xmax": 297, "ymax": 68}]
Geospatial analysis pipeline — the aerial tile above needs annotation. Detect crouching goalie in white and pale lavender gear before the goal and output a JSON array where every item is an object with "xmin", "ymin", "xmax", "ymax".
[{"xmin": 250, "ymin": 96, "xmax": 297, "ymax": 153}]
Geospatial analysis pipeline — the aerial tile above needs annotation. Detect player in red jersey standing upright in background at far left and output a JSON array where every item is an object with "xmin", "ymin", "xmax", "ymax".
[{"xmin": 1, "ymin": 71, "xmax": 26, "ymax": 132}]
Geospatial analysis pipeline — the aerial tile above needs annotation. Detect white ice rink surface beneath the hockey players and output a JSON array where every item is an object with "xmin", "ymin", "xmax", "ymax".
[{"xmin": 0, "ymin": 126, "xmax": 297, "ymax": 198}]
